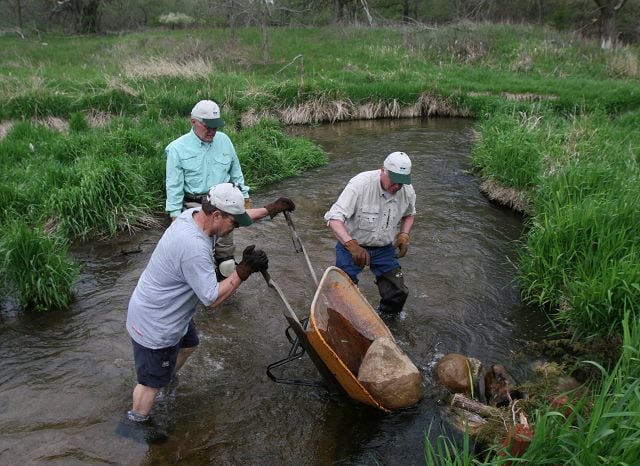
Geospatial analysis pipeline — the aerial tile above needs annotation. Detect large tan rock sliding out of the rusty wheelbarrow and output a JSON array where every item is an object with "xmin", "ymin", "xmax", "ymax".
[{"xmin": 358, "ymin": 337, "xmax": 422, "ymax": 410}]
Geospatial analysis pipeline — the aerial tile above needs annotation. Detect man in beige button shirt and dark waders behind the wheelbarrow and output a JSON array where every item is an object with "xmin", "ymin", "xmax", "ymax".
[{"xmin": 324, "ymin": 152, "xmax": 416, "ymax": 314}]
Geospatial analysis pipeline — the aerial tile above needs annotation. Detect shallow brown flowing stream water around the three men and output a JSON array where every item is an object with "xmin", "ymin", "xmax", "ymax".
[{"xmin": 0, "ymin": 119, "xmax": 542, "ymax": 465}]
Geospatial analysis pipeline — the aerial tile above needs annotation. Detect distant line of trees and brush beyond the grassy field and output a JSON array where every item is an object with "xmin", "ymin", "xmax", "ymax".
[{"xmin": 0, "ymin": 0, "xmax": 640, "ymax": 46}]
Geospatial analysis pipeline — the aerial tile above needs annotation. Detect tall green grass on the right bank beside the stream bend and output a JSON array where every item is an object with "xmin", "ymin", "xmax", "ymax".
[{"xmin": 474, "ymin": 108, "xmax": 640, "ymax": 337}]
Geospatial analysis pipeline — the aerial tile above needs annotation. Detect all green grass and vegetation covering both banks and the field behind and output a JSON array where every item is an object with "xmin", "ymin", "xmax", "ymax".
[{"xmin": 0, "ymin": 24, "xmax": 640, "ymax": 464}]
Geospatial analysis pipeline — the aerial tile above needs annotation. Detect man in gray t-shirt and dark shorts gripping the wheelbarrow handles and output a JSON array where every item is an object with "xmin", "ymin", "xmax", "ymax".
[{"xmin": 118, "ymin": 183, "xmax": 295, "ymax": 441}]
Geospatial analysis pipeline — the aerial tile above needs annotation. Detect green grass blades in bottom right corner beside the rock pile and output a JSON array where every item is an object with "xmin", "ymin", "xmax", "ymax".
[{"xmin": 425, "ymin": 309, "xmax": 640, "ymax": 465}]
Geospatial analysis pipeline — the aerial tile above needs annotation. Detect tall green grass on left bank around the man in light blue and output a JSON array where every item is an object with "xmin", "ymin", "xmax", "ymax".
[{"xmin": 0, "ymin": 112, "xmax": 326, "ymax": 310}]
